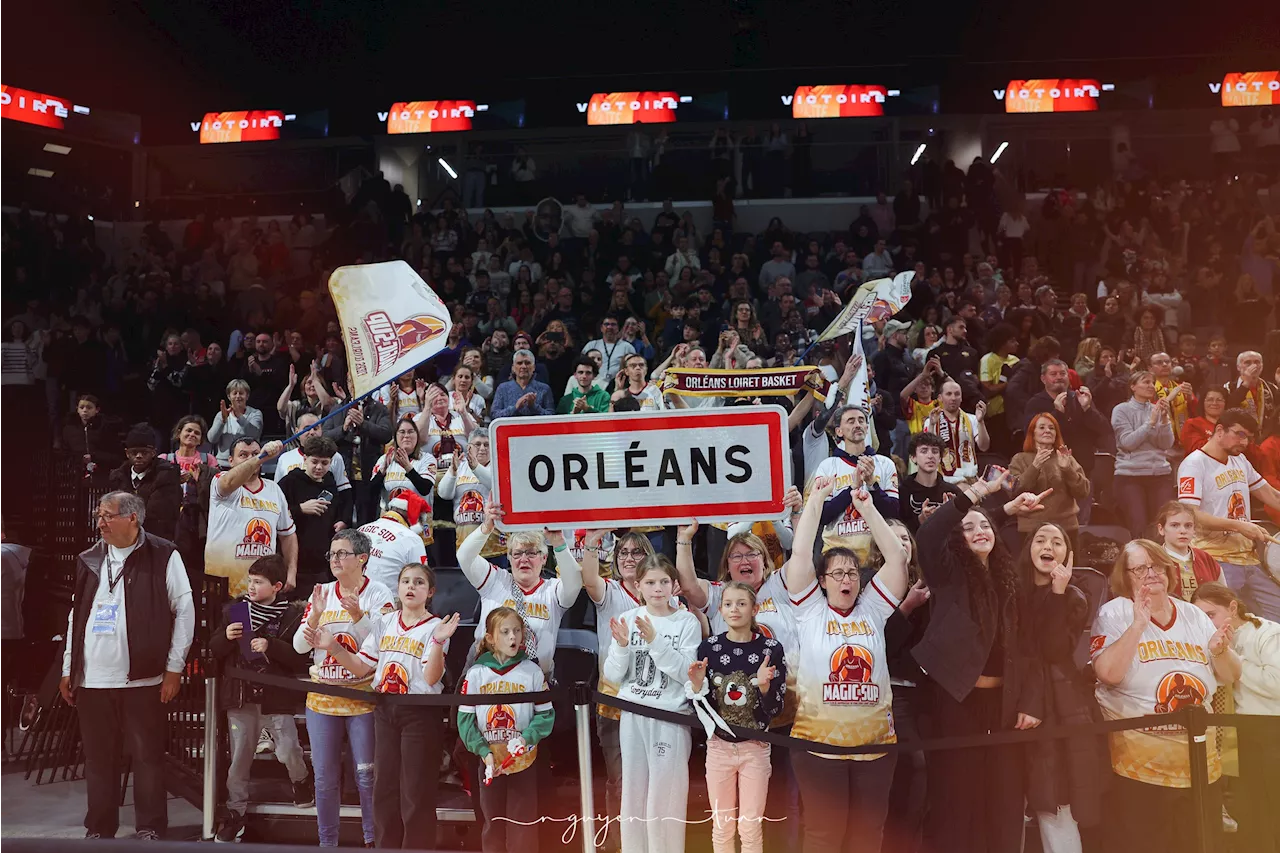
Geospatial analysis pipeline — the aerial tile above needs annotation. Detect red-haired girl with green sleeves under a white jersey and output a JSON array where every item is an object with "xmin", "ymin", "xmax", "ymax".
[{"xmin": 458, "ymin": 607, "xmax": 556, "ymax": 853}]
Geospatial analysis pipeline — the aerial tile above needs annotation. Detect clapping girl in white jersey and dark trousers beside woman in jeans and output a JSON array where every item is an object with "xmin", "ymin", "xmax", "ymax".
[{"xmin": 303, "ymin": 562, "xmax": 458, "ymax": 848}]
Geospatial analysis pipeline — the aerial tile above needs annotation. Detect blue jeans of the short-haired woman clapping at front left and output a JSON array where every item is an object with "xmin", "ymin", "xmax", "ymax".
[{"xmin": 307, "ymin": 708, "xmax": 374, "ymax": 847}]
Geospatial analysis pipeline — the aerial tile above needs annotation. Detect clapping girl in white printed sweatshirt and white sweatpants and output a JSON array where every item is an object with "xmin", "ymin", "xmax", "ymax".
[{"xmin": 604, "ymin": 556, "xmax": 703, "ymax": 853}]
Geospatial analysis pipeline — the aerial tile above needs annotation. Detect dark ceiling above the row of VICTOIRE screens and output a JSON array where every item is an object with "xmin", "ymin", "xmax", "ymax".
[{"xmin": 0, "ymin": 0, "xmax": 1280, "ymax": 117}]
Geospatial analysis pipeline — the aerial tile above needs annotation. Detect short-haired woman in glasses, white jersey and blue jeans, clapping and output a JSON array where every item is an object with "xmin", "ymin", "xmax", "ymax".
[{"xmin": 293, "ymin": 529, "xmax": 396, "ymax": 847}]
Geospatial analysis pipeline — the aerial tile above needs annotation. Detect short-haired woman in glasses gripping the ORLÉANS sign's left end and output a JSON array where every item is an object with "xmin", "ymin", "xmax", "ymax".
[{"xmin": 458, "ymin": 501, "xmax": 582, "ymax": 676}]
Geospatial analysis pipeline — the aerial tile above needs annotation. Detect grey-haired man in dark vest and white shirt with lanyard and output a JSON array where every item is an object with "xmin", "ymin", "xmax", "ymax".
[{"xmin": 59, "ymin": 492, "xmax": 196, "ymax": 840}]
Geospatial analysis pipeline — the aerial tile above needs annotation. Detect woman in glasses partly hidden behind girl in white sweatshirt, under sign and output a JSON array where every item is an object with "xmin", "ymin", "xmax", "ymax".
[{"xmin": 582, "ymin": 530, "xmax": 654, "ymax": 849}]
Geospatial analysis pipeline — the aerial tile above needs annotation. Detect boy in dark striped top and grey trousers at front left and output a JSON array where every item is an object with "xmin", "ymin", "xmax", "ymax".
[{"xmin": 209, "ymin": 555, "xmax": 315, "ymax": 841}]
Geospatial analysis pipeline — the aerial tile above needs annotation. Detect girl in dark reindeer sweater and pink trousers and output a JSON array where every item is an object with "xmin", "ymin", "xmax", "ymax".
[{"xmin": 687, "ymin": 580, "xmax": 787, "ymax": 853}]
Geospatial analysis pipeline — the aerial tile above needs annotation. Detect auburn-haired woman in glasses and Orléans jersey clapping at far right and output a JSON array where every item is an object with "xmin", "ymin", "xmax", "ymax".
[{"xmin": 1089, "ymin": 539, "xmax": 1240, "ymax": 850}]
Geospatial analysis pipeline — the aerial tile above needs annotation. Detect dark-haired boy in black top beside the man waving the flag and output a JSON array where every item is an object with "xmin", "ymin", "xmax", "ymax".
[{"xmin": 271, "ymin": 435, "xmax": 355, "ymax": 589}]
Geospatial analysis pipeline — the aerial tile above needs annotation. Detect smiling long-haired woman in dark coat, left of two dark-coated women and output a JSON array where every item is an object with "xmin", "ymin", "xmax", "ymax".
[{"xmin": 911, "ymin": 475, "xmax": 1047, "ymax": 853}]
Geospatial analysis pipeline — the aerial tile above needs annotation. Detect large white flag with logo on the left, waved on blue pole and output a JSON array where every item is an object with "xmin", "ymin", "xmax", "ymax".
[{"xmin": 329, "ymin": 260, "xmax": 453, "ymax": 398}]
